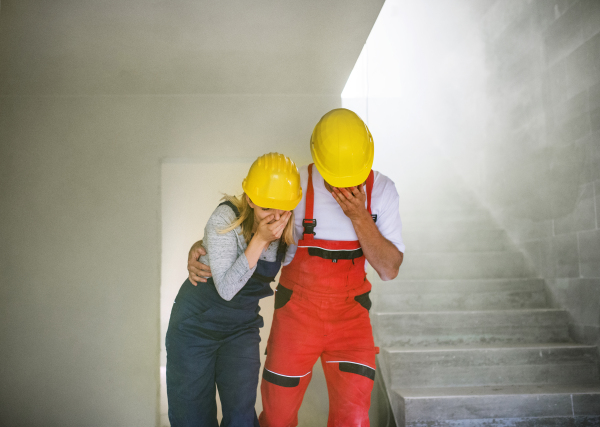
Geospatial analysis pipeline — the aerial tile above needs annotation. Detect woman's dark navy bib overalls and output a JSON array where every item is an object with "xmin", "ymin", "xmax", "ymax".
[{"xmin": 166, "ymin": 203, "xmax": 283, "ymax": 427}]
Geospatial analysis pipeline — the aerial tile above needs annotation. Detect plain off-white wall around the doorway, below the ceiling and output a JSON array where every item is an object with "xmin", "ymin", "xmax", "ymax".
[{"xmin": 0, "ymin": 92, "xmax": 340, "ymax": 426}]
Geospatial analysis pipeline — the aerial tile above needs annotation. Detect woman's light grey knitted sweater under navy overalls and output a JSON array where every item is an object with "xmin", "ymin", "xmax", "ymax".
[{"xmin": 200, "ymin": 205, "xmax": 279, "ymax": 301}]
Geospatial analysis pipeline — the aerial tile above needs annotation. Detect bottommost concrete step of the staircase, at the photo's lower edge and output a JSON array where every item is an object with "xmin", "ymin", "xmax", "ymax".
[{"xmin": 391, "ymin": 385, "xmax": 600, "ymax": 427}]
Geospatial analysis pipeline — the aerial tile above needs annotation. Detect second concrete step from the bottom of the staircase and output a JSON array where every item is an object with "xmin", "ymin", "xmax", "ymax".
[{"xmin": 381, "ymin": 344, "xmax": 600, "ymax": 388}]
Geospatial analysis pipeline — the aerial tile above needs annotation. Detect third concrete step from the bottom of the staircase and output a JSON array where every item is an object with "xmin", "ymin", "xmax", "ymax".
[{"xmin": 371, "ymin": 309, "xmax": 570, "ymax": 347}]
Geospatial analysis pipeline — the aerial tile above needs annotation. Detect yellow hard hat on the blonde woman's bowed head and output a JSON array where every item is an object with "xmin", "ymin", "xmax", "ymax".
[{"xmin": 242, "ymin": 153, "xmax": 302, "ymax": 211}]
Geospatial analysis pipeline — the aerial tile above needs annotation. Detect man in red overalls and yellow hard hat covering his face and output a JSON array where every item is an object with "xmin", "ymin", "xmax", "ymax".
[{"xmin": 188, "ymin": 109, "xmax": 404, "ymax": 427}]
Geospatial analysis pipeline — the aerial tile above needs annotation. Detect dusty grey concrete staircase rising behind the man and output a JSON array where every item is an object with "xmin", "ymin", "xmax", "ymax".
[{"xmin": 370, "ymin": 193, "xmax": 600, "ymax": 427}]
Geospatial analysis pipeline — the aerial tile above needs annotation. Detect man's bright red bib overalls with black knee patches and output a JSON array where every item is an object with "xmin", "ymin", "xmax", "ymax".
[{"xmin": 259, "ymin": 165, "xmax": 376, "ymax": 427}]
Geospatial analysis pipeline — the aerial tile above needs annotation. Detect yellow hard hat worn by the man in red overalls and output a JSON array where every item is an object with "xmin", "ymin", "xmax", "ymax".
[{"xmin": 310, "ymin": 108, "xmax": 374, "ymax": 187}]
